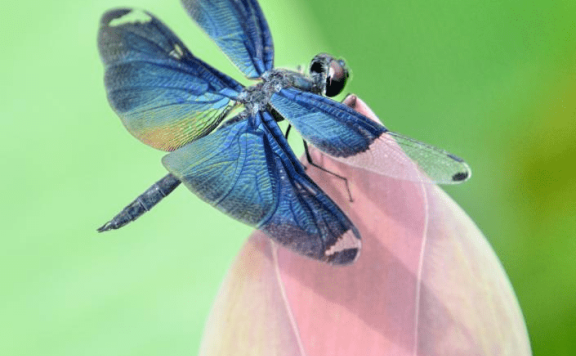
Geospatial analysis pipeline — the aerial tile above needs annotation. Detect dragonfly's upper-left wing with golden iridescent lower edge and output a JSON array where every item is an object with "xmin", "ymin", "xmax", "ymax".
[{"xmin": 98, "ymin": 9, "xmax": 242, "ymax": 151}]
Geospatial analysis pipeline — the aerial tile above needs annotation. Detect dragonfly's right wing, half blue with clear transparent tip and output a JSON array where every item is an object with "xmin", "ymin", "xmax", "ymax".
[{"xmin": 270, "ymin": 88, "xmax": 471, "ymax": 184}]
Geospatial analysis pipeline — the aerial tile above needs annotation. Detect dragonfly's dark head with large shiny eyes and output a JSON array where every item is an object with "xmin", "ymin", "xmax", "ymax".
[{"xmin": 310, "ymin": 53, "xmax": 350, "ymax": 97}]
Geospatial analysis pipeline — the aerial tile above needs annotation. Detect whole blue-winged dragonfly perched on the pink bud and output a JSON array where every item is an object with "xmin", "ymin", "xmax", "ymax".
[{"xmin": 98, "ymin": 0, "xmax": 471, "ymax": 265}]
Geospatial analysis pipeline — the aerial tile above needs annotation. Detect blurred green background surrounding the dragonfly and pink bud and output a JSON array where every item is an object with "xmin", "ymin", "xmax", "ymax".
[{"xmin": 0, "ymin": 0, "xmax": 576, "ymax": 356}]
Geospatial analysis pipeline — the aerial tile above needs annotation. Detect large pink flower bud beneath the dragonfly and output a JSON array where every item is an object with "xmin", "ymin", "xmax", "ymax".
[{"xmin": 200, "ymin": 98, "xmax": 531, "ymax": 356}]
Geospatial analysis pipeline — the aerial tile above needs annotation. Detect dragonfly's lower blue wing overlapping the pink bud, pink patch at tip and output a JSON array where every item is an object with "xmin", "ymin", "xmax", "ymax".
[{"xmin": 162, "ymin": 113, "xmax": 360, "ymax": 264}]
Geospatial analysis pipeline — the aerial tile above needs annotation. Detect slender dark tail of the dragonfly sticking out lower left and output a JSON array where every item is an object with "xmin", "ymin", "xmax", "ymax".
[{"xmin": 98, "ymin": 173, "xmax": 180, "ymax": 232}]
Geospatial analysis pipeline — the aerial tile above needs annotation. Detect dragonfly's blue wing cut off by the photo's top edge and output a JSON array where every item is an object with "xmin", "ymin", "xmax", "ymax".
[{"xmin": 182, "ymin": 0, "xmax": 274, "ymax": 79}]
